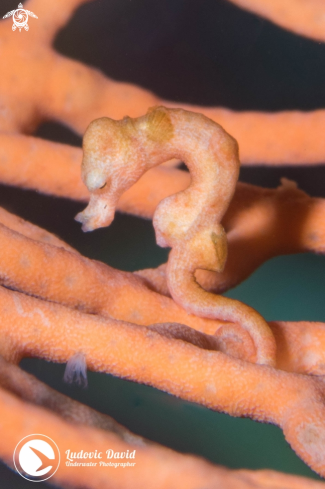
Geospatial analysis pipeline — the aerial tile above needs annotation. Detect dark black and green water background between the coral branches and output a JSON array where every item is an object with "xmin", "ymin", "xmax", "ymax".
[{"xmin": 0, "ymin": 0, "xmax": 325, "ymax": 482}]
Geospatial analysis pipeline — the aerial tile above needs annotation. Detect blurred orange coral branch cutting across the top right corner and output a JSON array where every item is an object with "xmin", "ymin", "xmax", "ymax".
[{"xmin": 229, "ymin": 0, "xmax": 325, "ymax": 42}]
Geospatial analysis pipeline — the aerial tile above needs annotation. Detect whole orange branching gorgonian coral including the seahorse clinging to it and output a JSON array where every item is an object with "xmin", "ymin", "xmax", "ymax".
[{"xmin": 0, "ymin": 0, "xmax": 325, "ymax": 489}]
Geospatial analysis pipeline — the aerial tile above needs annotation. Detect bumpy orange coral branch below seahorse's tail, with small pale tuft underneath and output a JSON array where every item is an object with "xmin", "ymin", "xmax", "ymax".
[{"xmin": 0, "ymin": 288, "xmax": 325, "ymax": 475}]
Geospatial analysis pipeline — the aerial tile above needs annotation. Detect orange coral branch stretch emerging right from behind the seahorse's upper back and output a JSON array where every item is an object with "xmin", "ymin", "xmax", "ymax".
[{"xmin": 185, "ymin": 107, "xmax": 325, "ymax": 166}]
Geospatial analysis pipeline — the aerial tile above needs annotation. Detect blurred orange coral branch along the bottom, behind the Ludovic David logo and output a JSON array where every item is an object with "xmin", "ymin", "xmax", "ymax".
[{"xmin": 0, "ymin": 389, "xmax": 324, "ymax": 489}]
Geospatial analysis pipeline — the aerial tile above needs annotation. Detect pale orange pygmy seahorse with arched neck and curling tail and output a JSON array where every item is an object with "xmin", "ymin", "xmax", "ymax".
[{"xmin": 76, "ymin": 107, "xmax": 275, "ymax": 365}]
